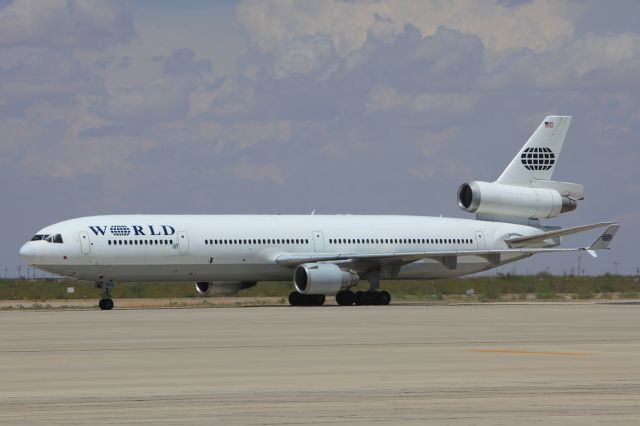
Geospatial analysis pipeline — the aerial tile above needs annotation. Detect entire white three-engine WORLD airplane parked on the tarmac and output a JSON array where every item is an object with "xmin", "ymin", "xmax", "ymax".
[{"xmin": 20, "ymin": 116, "xmax": 619, "ymax": 310}]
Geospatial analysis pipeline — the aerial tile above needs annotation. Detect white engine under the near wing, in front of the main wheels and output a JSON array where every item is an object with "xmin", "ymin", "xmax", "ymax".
[{"xmin": 293, "ymin": 263, "xmax": 360, "ymax": 294}]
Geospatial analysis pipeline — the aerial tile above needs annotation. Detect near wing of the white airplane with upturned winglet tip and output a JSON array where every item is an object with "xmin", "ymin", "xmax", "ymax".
[{"xmin": 276, "ymin": 224, "xmax": 620, "ymax": 269}]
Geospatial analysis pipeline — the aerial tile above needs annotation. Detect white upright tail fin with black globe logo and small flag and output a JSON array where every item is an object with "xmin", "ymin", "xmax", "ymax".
[{"xmin": 496, "ymin": 115, "xmax": 571, "ymax": 187}]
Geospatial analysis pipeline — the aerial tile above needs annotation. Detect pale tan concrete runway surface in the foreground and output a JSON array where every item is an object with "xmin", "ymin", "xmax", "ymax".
[{"xmin": 0, "ymin": 301, "xmax": 640, "ymax": 425}]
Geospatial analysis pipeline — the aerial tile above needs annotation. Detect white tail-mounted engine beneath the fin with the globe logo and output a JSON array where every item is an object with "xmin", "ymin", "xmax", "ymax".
[{"xmin": 458, "ymin": 181, "xmax": 577, "ymax": 219}]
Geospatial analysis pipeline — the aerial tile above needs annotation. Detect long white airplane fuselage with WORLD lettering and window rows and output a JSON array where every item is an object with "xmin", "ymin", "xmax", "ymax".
[{"xmin": 21, "ymin": 215, "xmax": 542, "ymax": 282}]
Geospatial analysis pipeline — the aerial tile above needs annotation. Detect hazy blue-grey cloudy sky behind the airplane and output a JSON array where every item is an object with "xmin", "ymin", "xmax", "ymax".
[{"xmin": 0, "ymin": 0, "xmax": 640, "ymax": 275}]
